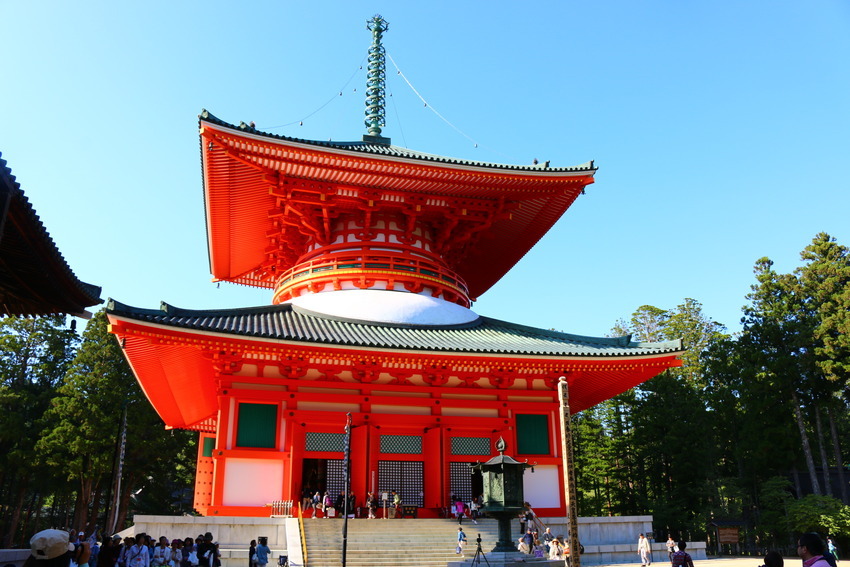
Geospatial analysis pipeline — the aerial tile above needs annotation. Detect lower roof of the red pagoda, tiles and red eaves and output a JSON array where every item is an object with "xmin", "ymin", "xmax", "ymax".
[{"xmin": 106, "ymin": 299, "xmax": 683, "ymax": 432}]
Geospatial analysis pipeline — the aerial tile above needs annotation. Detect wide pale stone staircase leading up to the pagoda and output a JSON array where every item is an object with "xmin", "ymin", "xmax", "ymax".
[{"xmin": 304, "ymin": 518, "xmax": 504, "ymax": 567}]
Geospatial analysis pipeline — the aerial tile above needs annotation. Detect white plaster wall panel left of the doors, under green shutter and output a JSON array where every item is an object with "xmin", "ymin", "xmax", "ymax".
[{"xmin": 222, "ymin": 459, "xmax": 283, "ymax": 508}]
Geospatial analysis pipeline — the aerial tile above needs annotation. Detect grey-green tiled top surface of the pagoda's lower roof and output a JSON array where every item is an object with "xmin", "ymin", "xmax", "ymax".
[{"xmin": 107, "ymin": 299, "xmax": 683, "ymax": 358}]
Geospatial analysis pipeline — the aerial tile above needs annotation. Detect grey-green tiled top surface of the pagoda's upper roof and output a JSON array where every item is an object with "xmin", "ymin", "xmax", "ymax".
[{"xmin": 198, "ymin": 109, "xmax": 598, "ymax": 173}]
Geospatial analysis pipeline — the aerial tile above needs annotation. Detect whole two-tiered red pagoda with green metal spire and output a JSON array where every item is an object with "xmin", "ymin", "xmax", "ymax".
[{"xmin": 108, "ymin": 16, "xmax": 682, "ymax": 516}]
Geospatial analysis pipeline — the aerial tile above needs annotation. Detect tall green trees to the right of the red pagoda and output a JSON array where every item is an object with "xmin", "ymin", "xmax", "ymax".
[{"xmin": 574, "ymin": 233, "xmax": 850, "ymax": 546}]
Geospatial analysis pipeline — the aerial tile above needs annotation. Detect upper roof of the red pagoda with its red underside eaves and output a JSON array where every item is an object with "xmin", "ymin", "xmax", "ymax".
[{"xmin": 199, "ymin": 111, "xmax": 596, "ymax": 299}]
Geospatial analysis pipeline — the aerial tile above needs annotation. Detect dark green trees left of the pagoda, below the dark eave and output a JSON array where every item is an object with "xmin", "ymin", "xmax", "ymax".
[{"xmin": 0, "ymin": 312, "xmax": 195, "ymax": 546}]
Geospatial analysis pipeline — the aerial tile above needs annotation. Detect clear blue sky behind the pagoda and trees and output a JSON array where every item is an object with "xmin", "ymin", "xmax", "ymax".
[{"xmin": 0, "ymin": 0, "xmax": 850, "ymax": 335}]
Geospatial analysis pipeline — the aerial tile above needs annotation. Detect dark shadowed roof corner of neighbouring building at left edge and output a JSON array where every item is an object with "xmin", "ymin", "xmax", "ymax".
[{"xmin": 0, "ymin": 154, "xmax": 102, "ymax": 317}]
